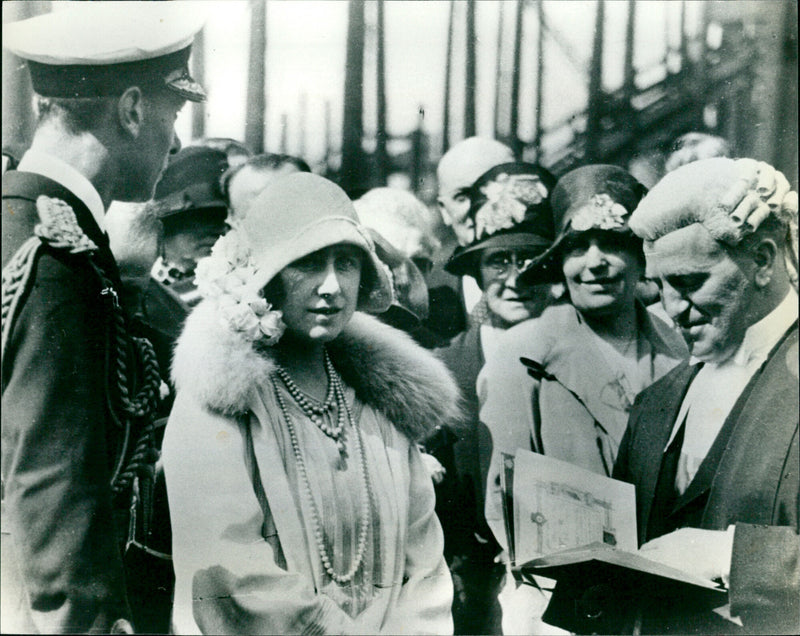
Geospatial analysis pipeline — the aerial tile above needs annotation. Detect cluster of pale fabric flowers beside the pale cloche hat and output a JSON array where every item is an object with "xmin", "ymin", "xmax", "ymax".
[{"xmin": 195, "ymin": 230, "xmax": 286, "ymax": 345}]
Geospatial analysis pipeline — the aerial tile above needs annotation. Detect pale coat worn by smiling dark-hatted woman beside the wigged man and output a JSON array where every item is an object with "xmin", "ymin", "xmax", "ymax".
[{"xmin": 477, "ymin": 304, "xmax": 688, "ymax": 546}]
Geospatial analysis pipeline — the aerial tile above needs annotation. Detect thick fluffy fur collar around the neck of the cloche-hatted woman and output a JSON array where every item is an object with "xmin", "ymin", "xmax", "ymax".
[{"xmin": 172, "ymin": 301, "xmax": 460, "ymax": 440}]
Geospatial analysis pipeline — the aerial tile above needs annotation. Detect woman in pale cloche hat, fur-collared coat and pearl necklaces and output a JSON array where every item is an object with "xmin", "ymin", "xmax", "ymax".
[{"xmin": 163, "ymin": 173, "xmax": 457, "ymax": 634}]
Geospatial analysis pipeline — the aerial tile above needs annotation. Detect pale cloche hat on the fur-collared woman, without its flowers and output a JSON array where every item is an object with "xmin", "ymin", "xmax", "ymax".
[{"xmin": 241, "ymin": 172, "xmax": 392, "ymax": 313}]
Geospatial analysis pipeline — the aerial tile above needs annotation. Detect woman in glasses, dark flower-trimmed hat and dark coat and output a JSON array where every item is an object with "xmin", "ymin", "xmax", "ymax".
[{"xmin": 428, "ymin": 162, "xmax": 555, "ymax": 634}]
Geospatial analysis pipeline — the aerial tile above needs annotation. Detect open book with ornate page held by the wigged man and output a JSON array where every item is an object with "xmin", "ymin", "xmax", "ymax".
[{"xmin": 501, "ymin": 450, "xmax": 727, "ymax": 607}]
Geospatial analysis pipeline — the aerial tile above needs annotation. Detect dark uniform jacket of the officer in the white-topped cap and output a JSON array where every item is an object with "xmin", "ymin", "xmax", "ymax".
[{"xmin": 2, "ymin": 171, "xmax": 130, "ymax": 633}]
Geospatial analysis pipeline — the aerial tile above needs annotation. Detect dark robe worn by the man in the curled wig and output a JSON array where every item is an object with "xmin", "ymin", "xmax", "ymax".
[{"xmin": 614, "ymin": 323, "xmax": 800, "ymax": 633}]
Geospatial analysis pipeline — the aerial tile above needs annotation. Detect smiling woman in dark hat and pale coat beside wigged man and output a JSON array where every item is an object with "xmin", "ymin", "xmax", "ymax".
[{"xmin": 478, "ymin": 165, "xmax": 687, "ymax": 536}]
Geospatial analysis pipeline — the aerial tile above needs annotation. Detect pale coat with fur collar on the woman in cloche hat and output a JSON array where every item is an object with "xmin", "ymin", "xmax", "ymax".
[{"xmin": 163, "ymin": 303, "xmax": 458, "ymax": 633}]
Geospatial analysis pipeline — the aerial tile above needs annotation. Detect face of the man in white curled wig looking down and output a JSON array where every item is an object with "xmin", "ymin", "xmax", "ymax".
[{"xmin": 647, "ymin": 224, "xmax": 755, "ymax": 362}]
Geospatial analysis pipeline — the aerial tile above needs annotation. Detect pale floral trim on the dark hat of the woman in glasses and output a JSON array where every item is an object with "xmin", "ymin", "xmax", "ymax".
[{"xmin": 475, "ymin": 173, "xmax": 548, "ymax": 239}]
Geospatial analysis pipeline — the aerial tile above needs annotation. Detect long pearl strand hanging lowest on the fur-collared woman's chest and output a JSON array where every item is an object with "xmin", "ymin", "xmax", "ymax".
[{"xmin": 270, "ymin": 377, "xmax": 371, "ymax": 585}]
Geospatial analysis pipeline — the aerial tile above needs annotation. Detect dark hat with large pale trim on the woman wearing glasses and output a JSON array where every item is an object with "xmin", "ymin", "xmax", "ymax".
[{"xmin": 445, "ymin": 162, "xmax": 556, "ymax": 276}]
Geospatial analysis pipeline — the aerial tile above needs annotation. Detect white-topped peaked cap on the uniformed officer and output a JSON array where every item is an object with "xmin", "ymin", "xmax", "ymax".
[{"xmin": 3, "ymin": 2, "xmax": 206, "ymax": 102}]
